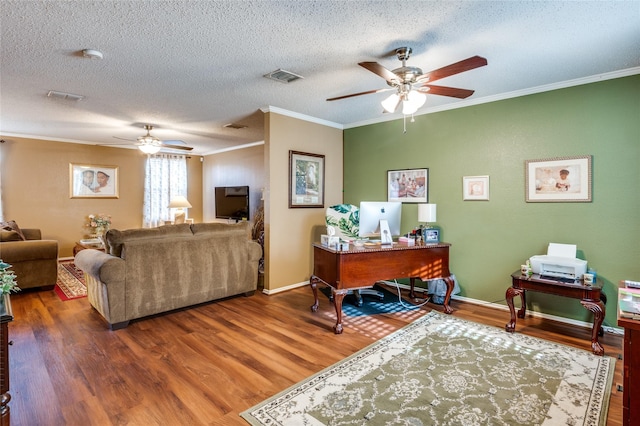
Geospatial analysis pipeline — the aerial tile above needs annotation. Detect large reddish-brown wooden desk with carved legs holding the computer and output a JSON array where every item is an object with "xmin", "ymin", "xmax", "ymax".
[{"xmin": 309, "ymin": 243, "xmax": 454, "ymax": 334}]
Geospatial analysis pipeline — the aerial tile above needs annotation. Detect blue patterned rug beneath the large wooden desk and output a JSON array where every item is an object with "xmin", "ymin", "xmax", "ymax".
[{"xmin": 320, "ymin": 286, "xmax": 419, "ymax": 317}]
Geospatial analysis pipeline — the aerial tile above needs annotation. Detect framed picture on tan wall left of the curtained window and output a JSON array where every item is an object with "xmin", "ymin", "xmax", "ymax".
[{"xmin": 69, "ymin": 163, "xmax": 119, "ymax": 198}]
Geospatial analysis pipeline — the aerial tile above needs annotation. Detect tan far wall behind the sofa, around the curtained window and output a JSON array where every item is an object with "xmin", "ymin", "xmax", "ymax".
[{"xmin": 0, "ymin": 137, "xmax": 202, "ymax": 257}]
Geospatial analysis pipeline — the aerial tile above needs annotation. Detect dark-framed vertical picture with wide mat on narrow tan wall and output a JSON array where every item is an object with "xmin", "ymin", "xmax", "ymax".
[{"xmin": 289, "ymin": 151, "xmax": 324, "ymax": 208}]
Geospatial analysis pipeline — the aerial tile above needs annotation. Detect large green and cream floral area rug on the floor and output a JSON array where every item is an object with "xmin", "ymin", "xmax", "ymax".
[{"xmin": 240, "ymin": 311, "xmax": 615, "ymax": 426}]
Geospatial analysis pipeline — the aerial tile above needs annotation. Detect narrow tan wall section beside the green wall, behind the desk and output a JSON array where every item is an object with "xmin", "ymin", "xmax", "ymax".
[{"xmin": 265, "ymin": 112, "xmax": 343, "ymax": 292}]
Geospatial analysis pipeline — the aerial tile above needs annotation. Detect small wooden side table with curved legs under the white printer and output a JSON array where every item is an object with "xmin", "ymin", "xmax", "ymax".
[{"xmin": 505, "ymin": 271, "xmax": 606, "ymax": 355}]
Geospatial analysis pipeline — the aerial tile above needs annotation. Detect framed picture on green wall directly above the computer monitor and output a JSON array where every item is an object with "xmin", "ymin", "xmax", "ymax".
[{"xmin": 387, "ymin": 168, "xmax": 429, "ymax": 203}]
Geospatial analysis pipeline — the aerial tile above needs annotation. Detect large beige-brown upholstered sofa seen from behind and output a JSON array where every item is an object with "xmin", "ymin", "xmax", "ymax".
[{"xmin": 75, "ymin": 222, "xmax": 262, "ymax": 330}]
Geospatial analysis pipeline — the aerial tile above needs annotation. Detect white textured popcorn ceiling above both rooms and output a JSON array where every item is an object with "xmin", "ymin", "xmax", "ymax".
[{"xmin": 0, "ymin": 0, "xmax": 640, "ymax": 154}]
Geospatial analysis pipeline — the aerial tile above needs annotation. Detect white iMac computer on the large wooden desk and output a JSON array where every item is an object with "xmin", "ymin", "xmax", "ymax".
[{"xmin": 358, "ymin": 201, "xmax": 402, "ymax": 244}]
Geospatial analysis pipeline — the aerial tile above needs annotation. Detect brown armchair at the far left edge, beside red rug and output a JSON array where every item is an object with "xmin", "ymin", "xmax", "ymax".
[{"xmin": 0, "ymin": 226, "xmax": 58, "ymax": 290}]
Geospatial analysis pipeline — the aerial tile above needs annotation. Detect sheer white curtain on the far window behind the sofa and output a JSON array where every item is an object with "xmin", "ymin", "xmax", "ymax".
[{"xmin": 142, "ymin": 154, "xmax": 187, "ymax": 228}]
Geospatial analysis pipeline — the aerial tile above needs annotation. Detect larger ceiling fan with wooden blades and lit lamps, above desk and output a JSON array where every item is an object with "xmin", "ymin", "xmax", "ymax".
[{"xmin": 327, "ymin": 47, "xmax": 487, "ymax": 116}]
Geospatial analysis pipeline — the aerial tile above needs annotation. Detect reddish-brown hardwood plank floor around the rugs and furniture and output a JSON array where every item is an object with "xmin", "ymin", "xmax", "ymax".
[{"xmin": 9, "ymin": 287, "xmax": 622, "ymax": 426}]
